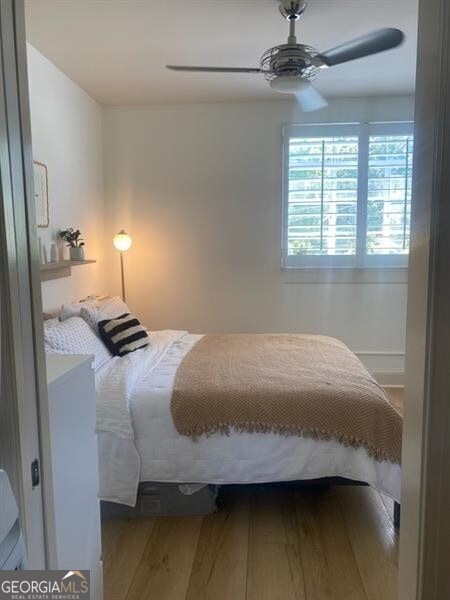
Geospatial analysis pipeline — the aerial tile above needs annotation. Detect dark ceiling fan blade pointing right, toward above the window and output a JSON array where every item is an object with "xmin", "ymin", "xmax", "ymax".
[{"xmin": 318, "ymin": 28, "xmax": 405, "ymax": 67}]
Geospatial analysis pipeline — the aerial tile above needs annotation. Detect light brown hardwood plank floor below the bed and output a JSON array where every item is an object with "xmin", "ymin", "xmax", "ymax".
[{"xmin": 102, "ymin": 392, "xmax": 401, "ymax": 600}]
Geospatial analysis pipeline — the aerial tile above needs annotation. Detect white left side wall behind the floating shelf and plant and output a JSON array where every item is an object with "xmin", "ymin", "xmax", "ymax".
[{"xmin": 28, "ymin": 45, "xmax": 105, "ymax": 311}]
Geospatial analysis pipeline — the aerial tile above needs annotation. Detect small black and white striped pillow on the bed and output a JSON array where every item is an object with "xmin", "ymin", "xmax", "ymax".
[{"xmin": 98, "ymin": 313, "xmax": 150, "ymax": 356}]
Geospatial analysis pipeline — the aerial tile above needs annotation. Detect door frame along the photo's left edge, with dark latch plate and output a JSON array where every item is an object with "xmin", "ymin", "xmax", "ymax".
[{"xmin": 0, "ymin": 0, "xmax": 51, "ymax": 569}]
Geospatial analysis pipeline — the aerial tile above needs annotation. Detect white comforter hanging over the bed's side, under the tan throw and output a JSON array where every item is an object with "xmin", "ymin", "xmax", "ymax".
[{"xmin": 96, "ymin": 331, "xmax": 401, "ymax": 506}]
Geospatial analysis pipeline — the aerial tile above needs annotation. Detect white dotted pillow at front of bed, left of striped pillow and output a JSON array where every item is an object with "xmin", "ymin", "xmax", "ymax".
[{"xmin": 44, "ymin": 317, "xmax": 112, "ymax": 370}]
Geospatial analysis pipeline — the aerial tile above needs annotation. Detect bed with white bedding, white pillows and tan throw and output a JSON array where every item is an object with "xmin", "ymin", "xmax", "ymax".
[{"xmin": 44, "ymin": 297, "xmax": 402, "ymax": 507}]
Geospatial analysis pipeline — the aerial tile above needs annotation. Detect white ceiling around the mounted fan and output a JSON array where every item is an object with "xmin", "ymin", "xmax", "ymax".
[{"xmin": 26, "ymin": 0, "xmax": 418, "ymax": 105}]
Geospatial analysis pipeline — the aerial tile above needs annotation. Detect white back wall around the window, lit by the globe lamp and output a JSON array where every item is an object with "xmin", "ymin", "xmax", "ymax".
[{"xmin": 104, "ymin": 97, "xmax": 413, "ymax": 369}]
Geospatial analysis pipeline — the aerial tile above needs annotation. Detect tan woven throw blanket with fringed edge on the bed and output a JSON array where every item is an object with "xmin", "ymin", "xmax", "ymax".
[{"xmin": 171, "ymin": 334, "xmax": 402, "ymax": 463}]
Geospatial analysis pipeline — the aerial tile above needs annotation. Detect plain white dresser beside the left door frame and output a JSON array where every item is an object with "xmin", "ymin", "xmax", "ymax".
[{"xmin": 44, "ymin": 354, "xmax": 103, "ymax": 600}]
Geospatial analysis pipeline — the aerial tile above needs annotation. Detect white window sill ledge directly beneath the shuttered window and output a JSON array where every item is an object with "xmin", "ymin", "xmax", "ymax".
[{"xmin": 282, "ymin": 267, "xmax": 408, "ymax": 285}]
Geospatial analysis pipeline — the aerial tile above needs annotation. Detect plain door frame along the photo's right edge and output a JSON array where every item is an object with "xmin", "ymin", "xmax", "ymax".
[{"xmin": 399, "ymin": 0, "xmax": 450, "ymax": 600}]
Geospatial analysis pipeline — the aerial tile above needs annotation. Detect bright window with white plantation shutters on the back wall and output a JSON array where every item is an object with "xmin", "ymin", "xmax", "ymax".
[{"xmin": 283, "ymin": 123, "xmax": 413, "ymax": 268}]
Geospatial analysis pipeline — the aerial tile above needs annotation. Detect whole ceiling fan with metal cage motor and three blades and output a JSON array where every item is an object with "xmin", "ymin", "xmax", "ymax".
[{"xmin": 167, "ymin": 0, "xmax": 404, "ymax": 112}]
